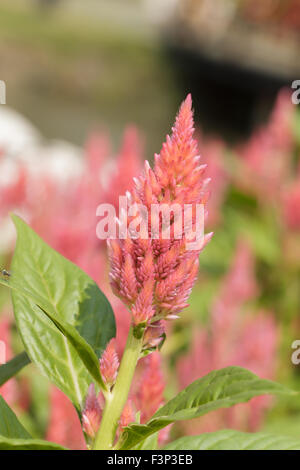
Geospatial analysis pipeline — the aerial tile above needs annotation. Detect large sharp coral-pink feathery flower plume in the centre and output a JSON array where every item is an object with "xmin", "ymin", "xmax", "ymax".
[{"xmin": 108, "ymin": 95, "xmax": 212, "ymax": 344}]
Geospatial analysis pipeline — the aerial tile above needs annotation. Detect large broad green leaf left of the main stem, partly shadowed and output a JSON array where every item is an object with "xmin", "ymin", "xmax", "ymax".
[{"xmin": 1, "ymin": 216, "xmax": 115, "ymax": 410}]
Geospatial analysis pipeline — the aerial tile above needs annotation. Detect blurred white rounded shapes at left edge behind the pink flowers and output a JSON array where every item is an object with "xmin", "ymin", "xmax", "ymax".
[{"xmin": 0, "ymin": 106, "xmax": 83, "ymax": 253}]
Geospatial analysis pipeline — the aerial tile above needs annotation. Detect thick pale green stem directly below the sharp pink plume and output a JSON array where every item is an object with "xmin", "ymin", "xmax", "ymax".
[{"xmin": 93, "ymin": 328, "xmax": 143, "ymax": 450}]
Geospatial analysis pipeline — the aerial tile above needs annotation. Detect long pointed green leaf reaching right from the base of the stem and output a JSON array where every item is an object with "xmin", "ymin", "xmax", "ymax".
[{"xmin": 118, "ymin": 367, "xmax": 294, "ymax": 449}]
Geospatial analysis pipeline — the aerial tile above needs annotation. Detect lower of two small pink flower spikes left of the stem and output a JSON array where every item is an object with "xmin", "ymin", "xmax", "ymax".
[{"xmin": 82, "ymin": 384, "xmax": 102, "ymax": 438}]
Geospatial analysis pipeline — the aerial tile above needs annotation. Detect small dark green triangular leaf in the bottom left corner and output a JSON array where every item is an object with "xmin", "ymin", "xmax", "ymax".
[{"xmin": 0, "ymin": 395, "xmax": 30, "ymax": 439}]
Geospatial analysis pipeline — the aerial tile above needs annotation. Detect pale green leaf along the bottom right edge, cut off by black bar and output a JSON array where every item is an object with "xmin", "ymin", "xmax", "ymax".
[{"xmin": 164, "ymin": 429, "xmax": 300, "ymax": 450}]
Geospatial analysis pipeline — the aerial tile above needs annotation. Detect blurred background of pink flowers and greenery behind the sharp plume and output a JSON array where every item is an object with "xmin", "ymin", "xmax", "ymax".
[{"xmin": 0, "ymin": 0, "xmax": 300, "ymax": 448}]
